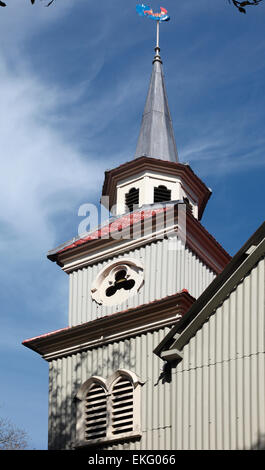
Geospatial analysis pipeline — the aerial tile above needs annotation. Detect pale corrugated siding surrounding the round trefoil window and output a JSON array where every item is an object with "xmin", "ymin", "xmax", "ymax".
[{"xmin": 69, "ymin": 239, "xmax": 212, "ymax": 326}]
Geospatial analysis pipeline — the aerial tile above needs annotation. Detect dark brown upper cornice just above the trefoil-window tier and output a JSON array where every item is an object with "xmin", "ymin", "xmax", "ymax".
[{"xmin": 50, "ymin": 209, "xmax": 231, "ymax": 274}]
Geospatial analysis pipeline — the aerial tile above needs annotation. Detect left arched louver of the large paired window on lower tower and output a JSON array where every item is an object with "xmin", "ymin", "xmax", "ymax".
[{"xmin": 85, "ymin": 383, "xmax": 107, "ymax": 441}]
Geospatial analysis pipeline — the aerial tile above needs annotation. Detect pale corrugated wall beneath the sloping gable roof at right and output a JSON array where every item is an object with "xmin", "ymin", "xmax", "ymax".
[{"xmin": 172, "ymin": 255, "xmax": 265, "ymax": 449}]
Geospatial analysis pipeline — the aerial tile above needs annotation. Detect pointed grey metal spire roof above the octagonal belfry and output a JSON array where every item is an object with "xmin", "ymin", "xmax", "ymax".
[{"xmin": 135, "ymin": 44, "xmax": 178, "ymax": 162}]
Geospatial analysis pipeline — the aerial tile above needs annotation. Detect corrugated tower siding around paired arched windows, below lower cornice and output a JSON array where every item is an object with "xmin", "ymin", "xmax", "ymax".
[{"xmin": 49, "ymin": 328, "xmax": 176, "ymax": 450}]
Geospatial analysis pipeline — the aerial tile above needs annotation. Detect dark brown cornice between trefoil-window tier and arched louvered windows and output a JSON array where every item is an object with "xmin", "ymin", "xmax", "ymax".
[{"xmin": 22, "ymin": 291, "xmax": 195, "ymax": 361}]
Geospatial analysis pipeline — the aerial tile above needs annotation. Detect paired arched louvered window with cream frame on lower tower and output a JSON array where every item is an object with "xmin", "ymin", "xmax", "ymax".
[{"xmin": 76, "ymin": 369, "xmax": 141, "ymax": 447}]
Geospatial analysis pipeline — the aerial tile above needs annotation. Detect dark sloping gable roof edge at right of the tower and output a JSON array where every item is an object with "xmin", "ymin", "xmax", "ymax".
[{"xmin": 154, "ymin": 222, "xmax": 265, "ymax": 360}]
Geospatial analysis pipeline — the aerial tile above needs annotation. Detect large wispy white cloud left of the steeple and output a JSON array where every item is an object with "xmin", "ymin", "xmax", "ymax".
[{"xmin": 0, "ymin": 0, "xmax": 144, "ymax": 277}]
